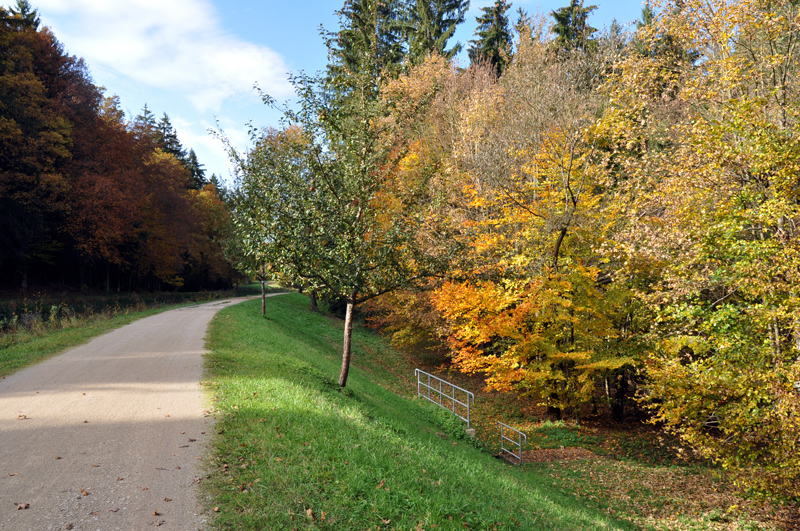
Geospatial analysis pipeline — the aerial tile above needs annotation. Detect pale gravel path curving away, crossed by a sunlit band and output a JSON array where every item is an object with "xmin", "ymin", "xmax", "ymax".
[{"xmin": 0, "ymin": 299, "xmax": 255, "ymax": 531}]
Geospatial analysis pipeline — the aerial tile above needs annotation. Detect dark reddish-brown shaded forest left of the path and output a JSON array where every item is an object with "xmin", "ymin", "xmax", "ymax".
[{"xmin": 0, "ymin": 0, "xmax": 238, "ymax": 295}]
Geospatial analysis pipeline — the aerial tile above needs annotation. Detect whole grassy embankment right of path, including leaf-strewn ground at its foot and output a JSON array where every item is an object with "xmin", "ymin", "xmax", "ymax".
[{"xmin": 203, "ymin": 295, "xmax": 792, "ymax": 531}]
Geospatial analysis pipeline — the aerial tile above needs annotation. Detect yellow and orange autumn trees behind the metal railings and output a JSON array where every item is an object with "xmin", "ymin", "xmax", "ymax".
[{"xmin": 356, "ymin": 0, "xmax": 800, "ymax": 500}]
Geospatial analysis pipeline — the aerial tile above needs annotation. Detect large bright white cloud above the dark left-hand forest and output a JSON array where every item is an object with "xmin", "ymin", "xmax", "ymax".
[{"xmin": 37, "ymin": 0, "xmax": 291, "ymax": 112}]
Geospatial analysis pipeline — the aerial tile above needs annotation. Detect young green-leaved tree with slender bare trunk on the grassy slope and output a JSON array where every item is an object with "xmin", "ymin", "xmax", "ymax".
[{"xmin": 231, "ymin": 6, "xmax": 438, "ymax": 387}]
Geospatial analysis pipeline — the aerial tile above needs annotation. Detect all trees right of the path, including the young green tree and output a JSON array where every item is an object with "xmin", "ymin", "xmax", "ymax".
[{"xmin": 231, "ymin": 0, "xmax": 800, "ymax": 500}]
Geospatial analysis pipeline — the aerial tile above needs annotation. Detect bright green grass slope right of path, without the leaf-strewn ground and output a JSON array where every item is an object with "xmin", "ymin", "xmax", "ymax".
[{"xmin": 204, "ymin": 295, "xmax": 634, "ymax": 530}]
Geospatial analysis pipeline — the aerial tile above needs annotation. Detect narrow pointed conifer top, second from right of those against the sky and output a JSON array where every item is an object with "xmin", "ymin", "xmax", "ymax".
[{"xmin": 469, "ymin": 0, "xmax": 511, "ymax": 76}]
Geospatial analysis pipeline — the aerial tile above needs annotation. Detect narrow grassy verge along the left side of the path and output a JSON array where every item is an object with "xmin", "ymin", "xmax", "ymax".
[{"xmin": 0, "ymin": 285, "xmax": 268, "ymax": 377}]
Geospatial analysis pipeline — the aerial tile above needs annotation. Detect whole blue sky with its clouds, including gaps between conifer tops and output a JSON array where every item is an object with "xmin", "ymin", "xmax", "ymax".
[{"xmin": 31, "ymin": 0, "xmax": 642, "ymax": 185}]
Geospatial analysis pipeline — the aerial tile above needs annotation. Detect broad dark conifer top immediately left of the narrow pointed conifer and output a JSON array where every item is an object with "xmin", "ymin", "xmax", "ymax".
[{"xmin": 403, "ymin": 0, "xmax": 469, "ymax": 63}]
